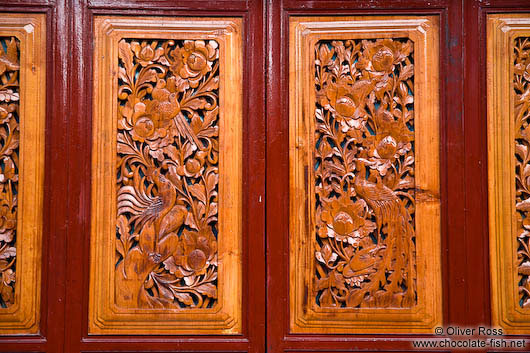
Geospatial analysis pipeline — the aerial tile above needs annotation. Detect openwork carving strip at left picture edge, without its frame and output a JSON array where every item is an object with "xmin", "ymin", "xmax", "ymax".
[{"xmin": 0, "ymin": 37, "xmax": 20, "ymax": 308}]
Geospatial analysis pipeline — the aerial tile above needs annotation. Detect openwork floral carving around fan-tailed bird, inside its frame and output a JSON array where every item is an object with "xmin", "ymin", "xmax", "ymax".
[{"xmin": 116, "ymin": 40, "xmax": 219, "ymax": 308}]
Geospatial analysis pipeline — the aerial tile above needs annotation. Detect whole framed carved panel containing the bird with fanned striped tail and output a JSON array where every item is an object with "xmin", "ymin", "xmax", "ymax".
[{"xmin": 89, "ymin": 16, "xmax": 242, "ymax": 334}]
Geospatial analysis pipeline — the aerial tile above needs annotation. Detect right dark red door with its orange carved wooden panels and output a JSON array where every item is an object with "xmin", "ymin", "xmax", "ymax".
[{"xmin": 266, "ymin": 0, "xmax": 530, "ymax": 352}]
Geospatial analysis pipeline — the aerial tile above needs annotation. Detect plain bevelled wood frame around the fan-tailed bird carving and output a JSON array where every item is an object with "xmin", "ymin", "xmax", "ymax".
[{"xmin": 89, "ymin": 16, "xmax": 243, "ymax": 334}]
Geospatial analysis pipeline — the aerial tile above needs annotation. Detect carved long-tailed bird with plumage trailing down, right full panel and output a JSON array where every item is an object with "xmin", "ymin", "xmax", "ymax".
[{"xmin": 353, "ymin": 158, "xmax": 416, "ymax": 305}]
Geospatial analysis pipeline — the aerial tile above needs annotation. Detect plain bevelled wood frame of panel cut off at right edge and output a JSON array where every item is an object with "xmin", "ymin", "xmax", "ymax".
[{"xmin": 487, "ymin": 14, "xmax": 530, "ymax": 334}]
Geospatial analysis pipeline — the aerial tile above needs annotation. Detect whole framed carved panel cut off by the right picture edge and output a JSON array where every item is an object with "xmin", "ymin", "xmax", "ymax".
[{"xmin": 487, "ymin": 14, "xmax": 530, "ymax": 334}]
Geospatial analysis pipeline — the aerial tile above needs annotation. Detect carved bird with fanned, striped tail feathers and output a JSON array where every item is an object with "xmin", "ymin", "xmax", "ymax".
[{"xmin": 118, "ymin": 170, "xmax": 186, "ymax": 256}]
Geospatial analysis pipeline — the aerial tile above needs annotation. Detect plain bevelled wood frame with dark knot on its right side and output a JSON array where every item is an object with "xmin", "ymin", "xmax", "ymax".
[{"xmin": 289, "ymin": 15, "xmax": 442, "ymax": 334}]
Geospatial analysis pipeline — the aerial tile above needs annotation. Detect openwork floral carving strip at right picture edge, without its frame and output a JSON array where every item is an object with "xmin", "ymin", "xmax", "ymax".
[{"xmin": 513, "ymin": 37, "xmax": 530, "ymax": 308}]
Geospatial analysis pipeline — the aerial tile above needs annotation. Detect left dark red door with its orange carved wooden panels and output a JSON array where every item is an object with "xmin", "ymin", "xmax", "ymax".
[{"xmin": 0, "ymin": 1, "xmax": 266, "ymax": 353}]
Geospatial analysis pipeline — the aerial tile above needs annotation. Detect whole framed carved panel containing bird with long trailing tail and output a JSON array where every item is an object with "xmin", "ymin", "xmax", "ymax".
[{"xmin": 289, "ymin": 16, "xmax": 442, "ymax": 333}]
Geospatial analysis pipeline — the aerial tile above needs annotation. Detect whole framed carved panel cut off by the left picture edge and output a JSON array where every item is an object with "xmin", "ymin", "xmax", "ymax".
[{"xmin": 0, "ymin": 14, "xmax": 46, "ymax": 334}]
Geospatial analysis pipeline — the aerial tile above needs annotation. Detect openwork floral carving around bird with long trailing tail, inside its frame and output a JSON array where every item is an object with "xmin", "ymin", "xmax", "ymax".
[{"xmin": 314, "ymin": 39, "xmax": 417, "ymax": 308}]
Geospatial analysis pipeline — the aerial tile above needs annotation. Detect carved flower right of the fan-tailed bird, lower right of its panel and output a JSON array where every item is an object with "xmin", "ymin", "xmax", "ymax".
[{"xmin": 173, "ymin": 229, "xmax": 217, "ymax": 276}]
